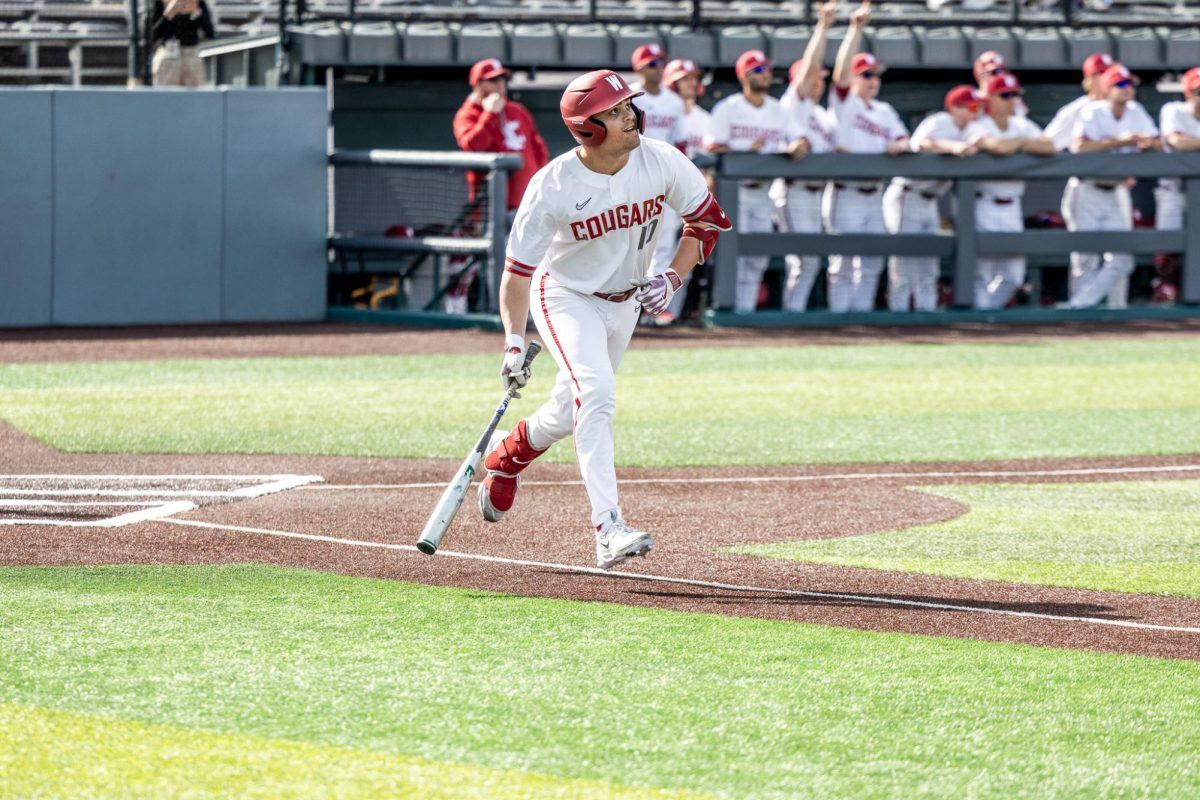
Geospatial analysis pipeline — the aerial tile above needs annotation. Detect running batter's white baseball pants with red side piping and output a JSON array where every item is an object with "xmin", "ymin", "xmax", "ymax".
[{"xmin": 526, "ymin": 270, "xmax": 640, "ymax": 525}]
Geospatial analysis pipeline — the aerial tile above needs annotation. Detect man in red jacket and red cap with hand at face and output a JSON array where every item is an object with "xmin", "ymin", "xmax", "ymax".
[{"xmin": 454, "ymin": 59, "xmax": 550, "ymax": 218}]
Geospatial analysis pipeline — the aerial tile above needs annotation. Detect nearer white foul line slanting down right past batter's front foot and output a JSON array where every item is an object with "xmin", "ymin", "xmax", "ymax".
[{"xmin": 160, "ymin": 519, "xmax": 1200, "ymax": 633}]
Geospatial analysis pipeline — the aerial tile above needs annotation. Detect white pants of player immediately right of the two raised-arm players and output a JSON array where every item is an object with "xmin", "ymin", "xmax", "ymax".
[{"xmin": 883, "ymin": 182, "xmax": 942, "ymax": 311}]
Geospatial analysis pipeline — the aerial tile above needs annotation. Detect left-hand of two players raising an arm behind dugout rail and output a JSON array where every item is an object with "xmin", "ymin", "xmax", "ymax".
[{"xmin": 770, "ymin": 0, "xmax": 838, "ymax": 311}]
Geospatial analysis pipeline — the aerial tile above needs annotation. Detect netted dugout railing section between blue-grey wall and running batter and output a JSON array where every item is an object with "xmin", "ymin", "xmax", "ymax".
[{"xmin": 329, "ymin": 150, "xmax": 521, "ymax": 321}]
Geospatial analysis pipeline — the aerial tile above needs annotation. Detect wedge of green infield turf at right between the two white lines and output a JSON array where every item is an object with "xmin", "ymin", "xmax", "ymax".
[{"xmin": 734, "ymin": 481, "xmax": 1200, "ymax": 599}]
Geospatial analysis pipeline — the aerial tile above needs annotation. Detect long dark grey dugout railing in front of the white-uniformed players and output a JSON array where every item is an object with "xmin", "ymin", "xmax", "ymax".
[{"xmin": 702, "ymin": 152, "xmax": 1200, "ymax": 324}]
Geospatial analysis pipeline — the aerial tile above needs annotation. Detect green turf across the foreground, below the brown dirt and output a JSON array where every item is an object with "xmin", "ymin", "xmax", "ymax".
[{"xmin": 0, "ymin": 566, "xmax": 1200, "ymax": 800}]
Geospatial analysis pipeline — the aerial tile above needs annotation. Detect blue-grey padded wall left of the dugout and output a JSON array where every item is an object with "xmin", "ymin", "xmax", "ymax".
[{"xmin": 0, "ymin": 89, "xmax": 326, "ymax": 326}]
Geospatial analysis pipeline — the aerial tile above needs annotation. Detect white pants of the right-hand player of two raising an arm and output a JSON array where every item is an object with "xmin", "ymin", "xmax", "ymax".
[{"xmin": 822, "ymin": 184, "xmax": 887, "ymax": 312}]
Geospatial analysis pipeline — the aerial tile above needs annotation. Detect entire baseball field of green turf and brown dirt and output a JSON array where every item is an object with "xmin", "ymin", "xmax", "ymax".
[{"xmin": 0, "ymin": 323, "xmax": 1200, "ymax": 799}]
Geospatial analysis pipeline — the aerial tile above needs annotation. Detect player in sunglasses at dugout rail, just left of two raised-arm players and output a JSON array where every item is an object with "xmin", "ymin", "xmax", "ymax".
[{"xmin": 708, "ymin": 50, "xmax": 809, "ymax": 314}]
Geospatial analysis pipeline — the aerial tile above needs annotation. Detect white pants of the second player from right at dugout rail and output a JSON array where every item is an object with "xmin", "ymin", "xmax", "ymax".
[{"xmin": 1068, "ymin": 181, "xmax": 1134, "ymax": 308}]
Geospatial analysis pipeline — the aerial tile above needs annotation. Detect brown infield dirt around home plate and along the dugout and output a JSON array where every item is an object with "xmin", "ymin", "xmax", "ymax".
[{"xmin": 0, "ymin": 323, "xmax": 1200, "ymax": 660}]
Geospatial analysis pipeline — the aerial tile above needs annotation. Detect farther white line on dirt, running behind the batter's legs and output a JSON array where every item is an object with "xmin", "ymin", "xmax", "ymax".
[{"xmin": 299, "ymin": 464, "xmax": 1200, "ymax": 492}]
